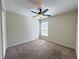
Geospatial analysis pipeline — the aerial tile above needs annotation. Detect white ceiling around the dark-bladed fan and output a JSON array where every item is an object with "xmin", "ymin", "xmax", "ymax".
[{"xmin": 5, "ymin": 0, "xmax": 78, "ymax": 17}]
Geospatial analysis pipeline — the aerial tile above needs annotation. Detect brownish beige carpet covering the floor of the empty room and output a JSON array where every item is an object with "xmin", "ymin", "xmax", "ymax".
[{"xmin": 5, "ymin": 39, "xmax": 77, "ymax": 59}]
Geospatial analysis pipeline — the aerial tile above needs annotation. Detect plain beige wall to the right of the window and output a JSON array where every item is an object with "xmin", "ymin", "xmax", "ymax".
[{"xmin": 41, "ymin": 11, "xmax": 77, "ymax": 48}]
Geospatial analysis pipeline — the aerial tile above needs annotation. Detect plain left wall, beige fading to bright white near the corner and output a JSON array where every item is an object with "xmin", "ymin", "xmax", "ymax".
[{"xmin": 6, "ymin": 12, "xmax": 39, "ymax": 47}]
